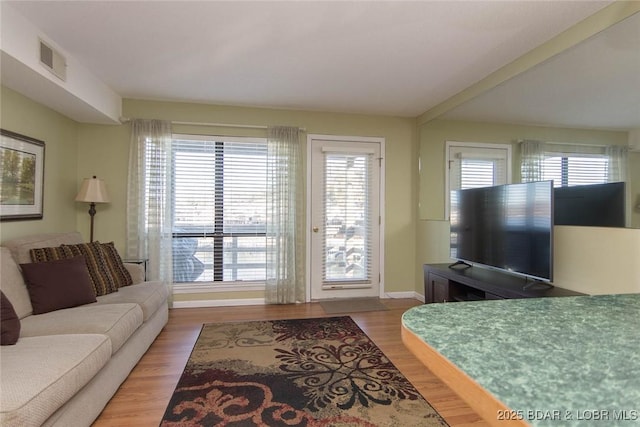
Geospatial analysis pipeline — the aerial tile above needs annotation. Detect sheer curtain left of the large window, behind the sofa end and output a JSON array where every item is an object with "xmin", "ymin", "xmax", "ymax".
[{"xmin": 126, "ymin": 119, "xmax": 173, "ymax": 298}]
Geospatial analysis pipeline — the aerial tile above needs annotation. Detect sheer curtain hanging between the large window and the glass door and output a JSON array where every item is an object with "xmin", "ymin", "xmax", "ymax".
[{"xmin": 265, "ymin": 127, "xmax": 306, "ymax": 304}]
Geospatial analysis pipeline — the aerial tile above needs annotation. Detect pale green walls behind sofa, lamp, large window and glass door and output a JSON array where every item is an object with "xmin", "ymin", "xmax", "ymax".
[{"xmin": 0, "ymin": 87, "xmax": 418, "ymax": 300}]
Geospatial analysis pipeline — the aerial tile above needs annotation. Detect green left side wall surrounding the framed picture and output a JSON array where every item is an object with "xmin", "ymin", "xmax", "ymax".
[{"xmin": 0, "ymin": 86, "xmax": 79, "ymax": 242}]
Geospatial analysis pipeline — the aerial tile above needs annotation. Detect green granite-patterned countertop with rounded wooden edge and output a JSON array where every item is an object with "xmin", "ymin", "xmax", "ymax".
[{"xmin": 402, "ymin": 294, "xmax": 640, "ymax": 426}]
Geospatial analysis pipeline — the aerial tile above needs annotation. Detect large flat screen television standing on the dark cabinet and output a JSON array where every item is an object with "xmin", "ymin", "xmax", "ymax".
[{"xmin": 450, "ymin": 181, "xmax": 554, "ymax": 282}]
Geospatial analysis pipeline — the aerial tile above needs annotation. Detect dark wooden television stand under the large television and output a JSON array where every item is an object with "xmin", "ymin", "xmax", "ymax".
[{"xmin": 423, "ymin": 264, "xmax": 584, "ymax": 303}]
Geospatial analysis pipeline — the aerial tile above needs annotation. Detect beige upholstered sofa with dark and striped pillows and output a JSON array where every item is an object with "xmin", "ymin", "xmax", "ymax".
[{"xmin": 0, "ymin": 233, "xmax": 168, "ymax": 427}]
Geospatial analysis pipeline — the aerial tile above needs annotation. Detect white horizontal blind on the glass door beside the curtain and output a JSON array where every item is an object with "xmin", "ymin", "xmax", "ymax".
[{"xmin": 322, "ymin": 152, "xmax": 374, "ymax": 286}]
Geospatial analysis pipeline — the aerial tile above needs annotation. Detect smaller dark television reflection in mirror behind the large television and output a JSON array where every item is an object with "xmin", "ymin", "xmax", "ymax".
[{"xmin": 554, "ymin": 182, "xmax": 626, "ymax": 227}]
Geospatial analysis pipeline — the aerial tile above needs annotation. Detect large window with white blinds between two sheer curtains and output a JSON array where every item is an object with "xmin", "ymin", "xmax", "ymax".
[{"xmin": 172, "ymin": 135, "xmax": 267, "ymax": 282}]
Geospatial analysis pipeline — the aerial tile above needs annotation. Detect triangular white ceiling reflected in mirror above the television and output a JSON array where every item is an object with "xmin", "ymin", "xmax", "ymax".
[{"xmin": 442, "ymin": 13, "xmax": 640, "ymax": 130}]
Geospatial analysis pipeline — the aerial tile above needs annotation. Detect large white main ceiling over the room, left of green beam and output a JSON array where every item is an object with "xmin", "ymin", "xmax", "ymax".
[{"xmin": 3, "ymin": 0, "xmax": 640, "ymax": 129}]
